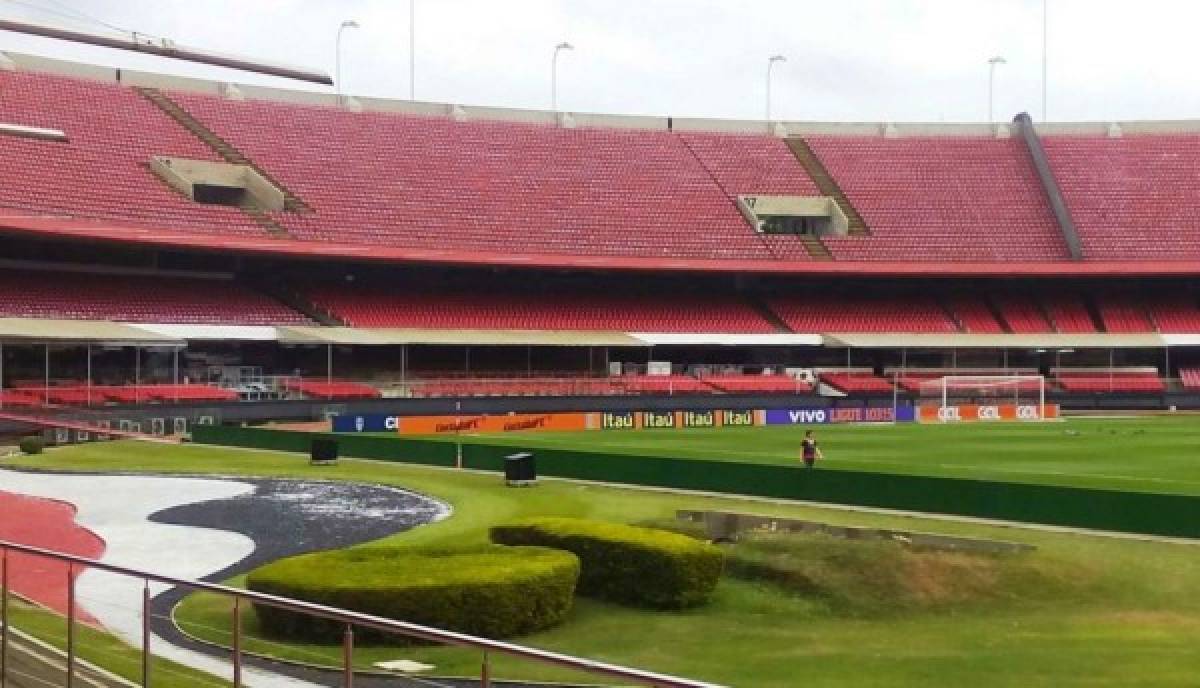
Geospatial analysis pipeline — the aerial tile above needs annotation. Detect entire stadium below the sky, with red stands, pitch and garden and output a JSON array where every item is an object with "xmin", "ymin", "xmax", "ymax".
[{"xmin": 0, "ymin": 5, "xmax": 1200, "ymax": 687}]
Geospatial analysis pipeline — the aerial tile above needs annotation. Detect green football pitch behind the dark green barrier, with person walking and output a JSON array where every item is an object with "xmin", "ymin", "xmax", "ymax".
[{"xmin": 410, "ymin": 415, "xmax": 1200, "ymax": 495}]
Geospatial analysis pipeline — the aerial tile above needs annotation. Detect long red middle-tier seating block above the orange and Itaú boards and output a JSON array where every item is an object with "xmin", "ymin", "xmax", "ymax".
[{"xmin": 308, "ymin": 286, "xmax": 775, "ymax": 333}]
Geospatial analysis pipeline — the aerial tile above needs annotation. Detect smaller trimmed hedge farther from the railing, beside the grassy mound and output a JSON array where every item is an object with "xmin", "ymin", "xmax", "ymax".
[{"xmin": 491, "ymin": 518, "xmax": 725, "ymax": 609}]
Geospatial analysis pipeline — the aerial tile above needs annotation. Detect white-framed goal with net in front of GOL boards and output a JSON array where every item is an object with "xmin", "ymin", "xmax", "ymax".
[{"xmin": 918, "ymin": 375, "xmax": 1048, "ymax": 421}]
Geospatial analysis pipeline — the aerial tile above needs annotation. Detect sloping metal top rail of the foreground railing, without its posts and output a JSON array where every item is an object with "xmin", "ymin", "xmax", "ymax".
[{"xmin": 0, "ymin": 540, "xmax": 722, "ymax": 688}]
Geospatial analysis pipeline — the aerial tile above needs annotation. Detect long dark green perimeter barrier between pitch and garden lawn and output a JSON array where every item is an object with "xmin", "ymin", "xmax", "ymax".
[{"xmin": 193, "ymin": 426, "xmax": 1200, "ymax": 538}]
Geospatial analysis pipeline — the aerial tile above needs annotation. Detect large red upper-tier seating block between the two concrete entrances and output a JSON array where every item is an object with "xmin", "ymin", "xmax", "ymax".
[{"xmin": 174, "ymin": 94, "xmax": 782, "ymax": 259}]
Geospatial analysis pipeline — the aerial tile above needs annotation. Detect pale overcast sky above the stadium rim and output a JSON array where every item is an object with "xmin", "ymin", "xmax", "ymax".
[{"xmin": 0, "ymin": 0, "xmax": 1200, "ymax": 121}]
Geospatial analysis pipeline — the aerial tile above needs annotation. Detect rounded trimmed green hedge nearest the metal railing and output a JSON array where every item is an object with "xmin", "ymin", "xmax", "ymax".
[{"xmin": 246, "ymin": 545, "xmax": 580, "ymax": 642}]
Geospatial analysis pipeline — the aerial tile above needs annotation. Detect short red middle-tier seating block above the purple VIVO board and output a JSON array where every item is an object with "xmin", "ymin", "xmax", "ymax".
[{"xmin": 769, "ymin": 293, "xmax": 958, "ymax": 333}]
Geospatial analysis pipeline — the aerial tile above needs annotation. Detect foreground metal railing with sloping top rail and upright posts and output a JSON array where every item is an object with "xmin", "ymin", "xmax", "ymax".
[{"xmin": 0, "ymin": 540, "xmax": 721, "ymax": 688}]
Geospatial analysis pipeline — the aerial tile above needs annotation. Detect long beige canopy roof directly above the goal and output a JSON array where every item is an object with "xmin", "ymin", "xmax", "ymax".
[{"xmin": 824, "ymin": 333, "xmax": 1168, "ymax": 351}]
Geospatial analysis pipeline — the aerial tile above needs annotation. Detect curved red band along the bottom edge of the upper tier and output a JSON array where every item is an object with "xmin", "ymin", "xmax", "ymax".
[{"xmin": 7, "ymin": 210, "xmax": 1200, "ymax": 277}]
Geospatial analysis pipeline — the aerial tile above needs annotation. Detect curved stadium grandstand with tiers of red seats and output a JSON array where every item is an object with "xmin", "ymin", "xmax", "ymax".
[{"xmin": 0, "ymin": 49, "xmax": 1200, "ymax": 434}]
